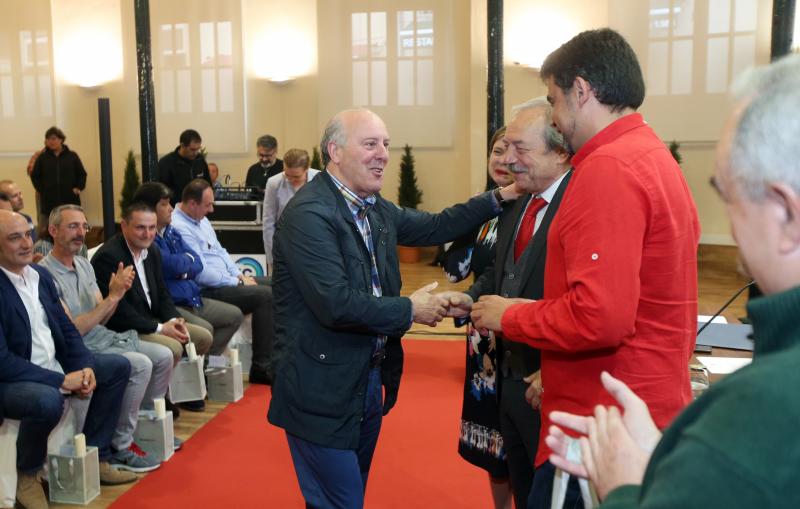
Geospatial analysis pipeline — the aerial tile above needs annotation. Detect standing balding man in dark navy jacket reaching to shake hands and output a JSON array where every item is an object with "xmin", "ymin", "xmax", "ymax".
[{"xmin": 269, "ymin": 110, "xmax": 516, "ymax": 508}]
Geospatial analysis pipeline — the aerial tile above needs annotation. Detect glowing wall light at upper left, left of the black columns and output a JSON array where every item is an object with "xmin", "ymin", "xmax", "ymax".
[{"xmin": 52, "ymin": 0, "xmax": 123, "ymax": 88}]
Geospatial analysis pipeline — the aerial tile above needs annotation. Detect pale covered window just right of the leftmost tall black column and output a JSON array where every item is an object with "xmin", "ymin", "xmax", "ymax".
[{"xmin": 151, "ymin": 0, "xmax": 247, "ymax": 157}]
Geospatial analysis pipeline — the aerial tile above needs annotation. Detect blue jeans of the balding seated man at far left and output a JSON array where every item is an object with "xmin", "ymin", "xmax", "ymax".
[{"xmin": 0, "ymin": 354, "xmax": 131, "ymax": 474}]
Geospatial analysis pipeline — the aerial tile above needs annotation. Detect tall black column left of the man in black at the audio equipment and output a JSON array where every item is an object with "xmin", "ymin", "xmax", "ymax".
[{"xmin": 133, "ymin": 0, "xmax": 158, "ymax": 182}]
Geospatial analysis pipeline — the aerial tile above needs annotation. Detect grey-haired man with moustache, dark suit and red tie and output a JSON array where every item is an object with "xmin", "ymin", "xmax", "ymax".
[{"xmin": 440, "ymin": 99, "xmax": 570, "ymax": 507}]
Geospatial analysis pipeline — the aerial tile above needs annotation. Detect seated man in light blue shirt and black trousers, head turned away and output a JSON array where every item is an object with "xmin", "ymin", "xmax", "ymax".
[{"xmin": 172, "ymin": 179, "xmax": 274, "ymax": 384}]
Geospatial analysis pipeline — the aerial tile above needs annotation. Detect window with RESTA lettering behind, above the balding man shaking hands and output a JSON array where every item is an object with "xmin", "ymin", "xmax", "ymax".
[{"xmin": 351, "ymin": 10, "xmax": 435, "ymax": 106}]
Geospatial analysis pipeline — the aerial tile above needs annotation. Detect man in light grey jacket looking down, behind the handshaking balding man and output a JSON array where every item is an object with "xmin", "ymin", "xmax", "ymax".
[{"xmin": 263, "ymin": 148, "xmax": 319, "ymax": 274}]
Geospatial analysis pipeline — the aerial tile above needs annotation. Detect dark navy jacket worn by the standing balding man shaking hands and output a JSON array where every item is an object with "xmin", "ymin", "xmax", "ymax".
[{"xmin": 268, "ymin": 171, "xmax": 499, "ymax": 449}]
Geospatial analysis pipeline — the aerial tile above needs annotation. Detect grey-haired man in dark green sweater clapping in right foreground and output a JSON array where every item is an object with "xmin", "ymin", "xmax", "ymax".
[{"xmin": 547, "ymin": 55, "xmax": 800, "ymax": 509}]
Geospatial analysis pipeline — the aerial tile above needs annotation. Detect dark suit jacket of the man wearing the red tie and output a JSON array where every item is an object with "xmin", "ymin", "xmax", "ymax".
[{"xmin": 467, "ymin": 170, "xmax": 572, "ymax": 374}]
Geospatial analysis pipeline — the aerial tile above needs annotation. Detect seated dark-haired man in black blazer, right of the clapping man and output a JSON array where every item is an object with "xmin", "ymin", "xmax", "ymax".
[{"xmin": 92, "ymin": 202, "xmax": 211, "ymax": 363}]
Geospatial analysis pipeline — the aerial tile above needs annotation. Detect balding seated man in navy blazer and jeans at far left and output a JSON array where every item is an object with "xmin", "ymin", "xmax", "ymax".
[{"xmin": 0, "ymin": 210, "xmax": 136, "ymax": 507}]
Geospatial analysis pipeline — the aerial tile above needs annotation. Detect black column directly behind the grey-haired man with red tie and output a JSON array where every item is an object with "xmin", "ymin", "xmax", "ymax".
[{"xmin": 486, "ymin": 0, "xmax": 505, "ymax": 189}]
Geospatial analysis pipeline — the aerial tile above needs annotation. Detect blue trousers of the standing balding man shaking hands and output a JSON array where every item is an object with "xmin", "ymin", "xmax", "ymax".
[{"xmin": 286, "ymin": 368, "xmax": 383, "ymax": 509}]
